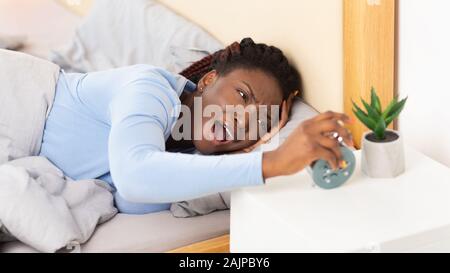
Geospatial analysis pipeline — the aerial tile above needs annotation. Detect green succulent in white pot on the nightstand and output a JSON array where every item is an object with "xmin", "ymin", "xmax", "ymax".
[{"xmin": 353, "ymin": 87, "xmax": 408, "ymax": 178}]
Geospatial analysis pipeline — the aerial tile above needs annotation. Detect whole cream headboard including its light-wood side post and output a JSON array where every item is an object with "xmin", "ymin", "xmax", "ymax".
[{"xmin": 56, "ymin": 0, "xmax": 396, "ymax": 147}]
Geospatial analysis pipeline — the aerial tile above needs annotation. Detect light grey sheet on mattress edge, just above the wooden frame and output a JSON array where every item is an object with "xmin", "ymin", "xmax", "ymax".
[{"xmin": 0, "ymin": 210, "xmax": 230, "ymax": 253}]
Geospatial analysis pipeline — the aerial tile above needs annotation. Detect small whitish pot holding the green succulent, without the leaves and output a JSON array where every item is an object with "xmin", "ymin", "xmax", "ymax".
[{"xmin": 361, "ymin": 130, "xmax": 405, "ymax": 178}]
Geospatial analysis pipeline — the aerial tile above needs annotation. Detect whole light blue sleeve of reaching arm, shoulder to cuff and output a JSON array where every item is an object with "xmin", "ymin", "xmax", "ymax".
[{"xmin": 108, "ymin": 73, "xmax": 264, "ymax": 203}]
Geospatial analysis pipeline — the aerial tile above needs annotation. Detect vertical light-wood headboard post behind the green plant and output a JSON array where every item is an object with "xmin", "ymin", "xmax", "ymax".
[{"xmin": 344, "ymin": 0, "xmax": 396, "ymax": 148}]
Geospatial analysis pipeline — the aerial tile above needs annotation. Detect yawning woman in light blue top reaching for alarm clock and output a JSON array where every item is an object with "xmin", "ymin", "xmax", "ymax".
[{"xmin": 40, "ymin": 38, "xmax": 352, "ymax": 214}]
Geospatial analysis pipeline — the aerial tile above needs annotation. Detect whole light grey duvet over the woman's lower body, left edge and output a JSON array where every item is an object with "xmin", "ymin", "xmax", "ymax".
[{"xmin": 0, "ymin": 49, "xmax": 117, "ymax": 252}]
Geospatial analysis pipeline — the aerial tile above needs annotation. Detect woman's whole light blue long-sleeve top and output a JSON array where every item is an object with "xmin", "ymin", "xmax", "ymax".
[{"xmin": 40, "ymin": 65, "xmax": 264, "ymax": 213}]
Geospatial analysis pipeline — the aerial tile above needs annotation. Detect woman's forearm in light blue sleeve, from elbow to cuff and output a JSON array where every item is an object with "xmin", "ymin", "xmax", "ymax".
[{"xmin": 111, "ymin": 150, "xmax": 264, "ymax": 203}]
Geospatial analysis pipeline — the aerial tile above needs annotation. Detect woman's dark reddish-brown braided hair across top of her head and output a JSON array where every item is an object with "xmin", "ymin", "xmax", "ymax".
[{"xmin": 180, "ymin": 38, "xmax": 301, "ymax": 99}]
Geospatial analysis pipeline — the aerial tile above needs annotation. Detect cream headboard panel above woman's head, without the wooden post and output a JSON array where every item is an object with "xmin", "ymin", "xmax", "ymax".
[{"xmin": 159, "ymin": 0, "xmax": 343, "ymax": 111}]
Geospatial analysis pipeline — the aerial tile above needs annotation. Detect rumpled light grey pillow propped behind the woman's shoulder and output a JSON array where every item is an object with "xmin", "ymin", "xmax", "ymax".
[{"xmin": 50, "ymin": 0, "xmax": 223, "ymax": 73}]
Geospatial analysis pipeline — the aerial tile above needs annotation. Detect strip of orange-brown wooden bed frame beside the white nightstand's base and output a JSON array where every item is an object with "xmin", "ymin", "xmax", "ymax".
[{"xmin": 168, "ymin": 235, "xmax": 230, "ymax": 253}]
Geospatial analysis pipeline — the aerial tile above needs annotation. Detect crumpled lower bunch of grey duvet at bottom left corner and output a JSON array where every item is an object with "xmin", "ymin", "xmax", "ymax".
[{"xmin": 0, "ymin": 156, "xmax": 117, "ymax": 252}]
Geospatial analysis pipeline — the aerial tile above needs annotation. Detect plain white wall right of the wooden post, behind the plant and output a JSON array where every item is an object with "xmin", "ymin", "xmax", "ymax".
[{"xmin": 398, "ymin": 0, "xmax": 450, "ymax": 167}]
